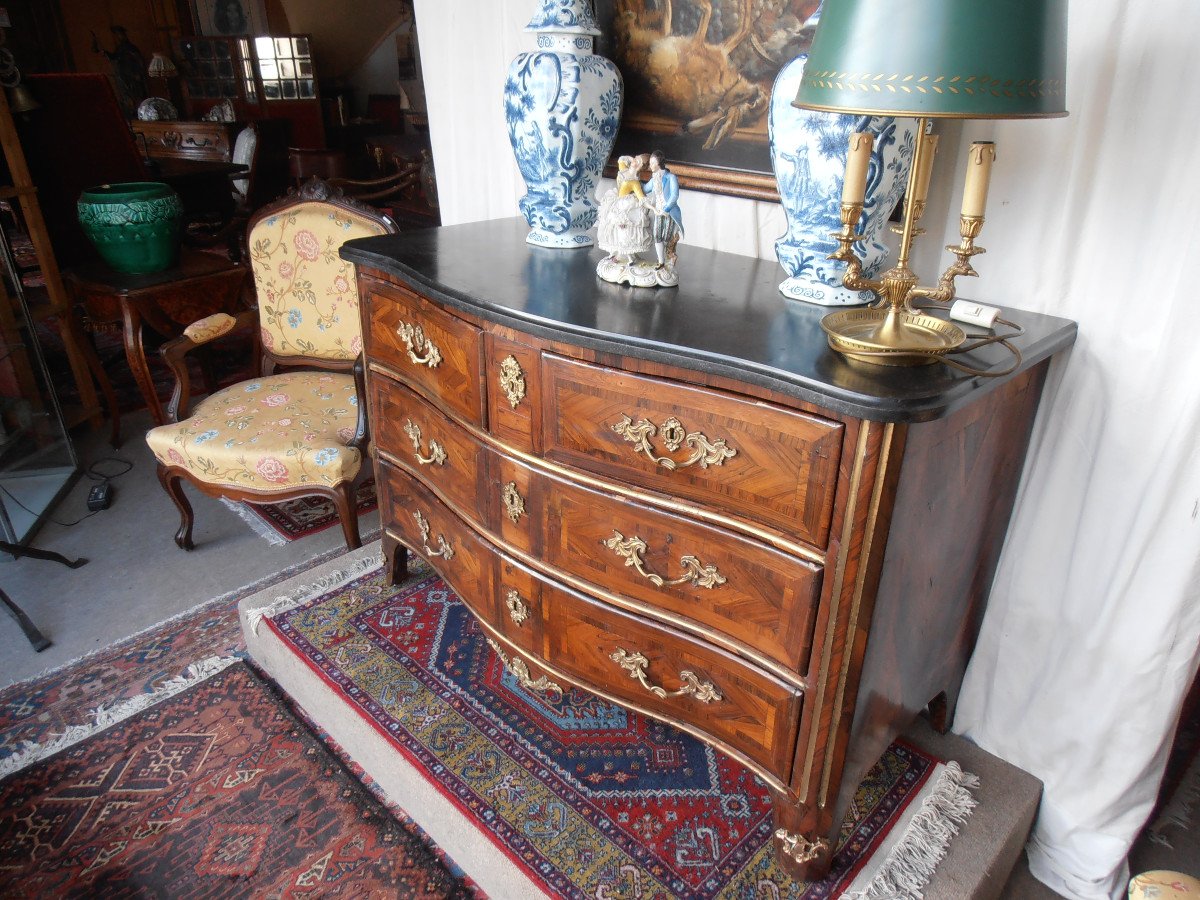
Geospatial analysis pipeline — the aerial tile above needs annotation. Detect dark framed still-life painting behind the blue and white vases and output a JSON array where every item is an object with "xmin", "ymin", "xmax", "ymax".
[{"xmin": 595, "ymin": 0, "xmax": 821, "ymax": 200}]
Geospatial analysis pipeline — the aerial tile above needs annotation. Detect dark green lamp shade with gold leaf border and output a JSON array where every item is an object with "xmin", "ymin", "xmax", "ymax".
[{"xmin": 796, "ymin": 0, "xmax": 1067, "ymax": 119}]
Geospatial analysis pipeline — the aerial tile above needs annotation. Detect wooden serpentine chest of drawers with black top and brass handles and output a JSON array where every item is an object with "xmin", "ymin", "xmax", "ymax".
[{"xmin": 342, "ymin": 220, "xmax": 1075, "ymax": 877}]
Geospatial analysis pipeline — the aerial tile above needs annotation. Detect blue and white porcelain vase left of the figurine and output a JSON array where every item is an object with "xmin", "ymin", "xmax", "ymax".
[{"xmin": 504, "ymin": 0, "xmax": 622, "ymax": 248}]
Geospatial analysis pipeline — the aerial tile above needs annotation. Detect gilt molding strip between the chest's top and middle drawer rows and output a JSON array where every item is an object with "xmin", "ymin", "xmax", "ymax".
[{"xmin": 368, "ymin": 376, "xmax": 839, "ymax": 568}]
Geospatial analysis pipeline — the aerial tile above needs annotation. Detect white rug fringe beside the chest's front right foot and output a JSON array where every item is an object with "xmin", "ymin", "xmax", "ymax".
[{"xmin": 845, "ymin": 762, "xmax": 979, "ymax": 900}]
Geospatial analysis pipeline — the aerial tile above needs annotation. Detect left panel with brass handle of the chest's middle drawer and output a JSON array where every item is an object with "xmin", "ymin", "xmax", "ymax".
[{"xmin": 368, "ymin": 373, "xmax": 486, "ymax": 525}]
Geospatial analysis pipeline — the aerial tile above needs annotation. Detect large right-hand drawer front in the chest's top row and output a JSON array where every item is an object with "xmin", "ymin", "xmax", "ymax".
[{"xmin": 541, "ymin": 354, "xmax": 842, "ymax": 547}]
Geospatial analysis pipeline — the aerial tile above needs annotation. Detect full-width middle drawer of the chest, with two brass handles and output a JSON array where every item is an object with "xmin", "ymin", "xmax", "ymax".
[{"xmin": 371, "ymin": 378, "xmax": 822, "ymax": 673}]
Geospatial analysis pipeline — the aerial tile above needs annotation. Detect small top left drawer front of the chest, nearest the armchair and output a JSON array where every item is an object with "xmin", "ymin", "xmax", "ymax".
[{"xmin": 359, "ymin": 278, "xmax": 484, "ymax": 425}]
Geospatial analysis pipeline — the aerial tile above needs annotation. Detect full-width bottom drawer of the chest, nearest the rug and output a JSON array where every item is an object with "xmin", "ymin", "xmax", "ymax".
[{"xmin": 380, "ymin": 463, "xmax": 800, "ymax": 773}]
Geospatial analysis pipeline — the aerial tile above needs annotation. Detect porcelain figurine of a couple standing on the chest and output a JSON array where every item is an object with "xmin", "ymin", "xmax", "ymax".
[{"xmin": 596, "ymin": 151, "xmax": 683, "ymax": 288}]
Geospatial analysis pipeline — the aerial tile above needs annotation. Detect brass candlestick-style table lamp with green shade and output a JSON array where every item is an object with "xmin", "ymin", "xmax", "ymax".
[{"xmin": 794, "ymin": 0, "xmax": 1067, "ymax": 366}]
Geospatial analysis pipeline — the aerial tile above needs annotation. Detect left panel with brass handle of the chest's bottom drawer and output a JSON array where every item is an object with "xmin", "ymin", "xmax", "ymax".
[{"xmin": 377, "ymin": 462, "xmax": 496, "ymax": 622}]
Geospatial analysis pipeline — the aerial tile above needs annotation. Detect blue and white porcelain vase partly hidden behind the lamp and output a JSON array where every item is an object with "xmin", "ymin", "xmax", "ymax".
[{"xmin": 767, "ymin": 55, "xmax": 917, "ymax": 306}]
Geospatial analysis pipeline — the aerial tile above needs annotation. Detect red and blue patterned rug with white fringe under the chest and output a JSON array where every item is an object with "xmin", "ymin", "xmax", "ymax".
[{"xmin": 258, "ymin": 570, "xmax": 977, "ymax": 900}]
